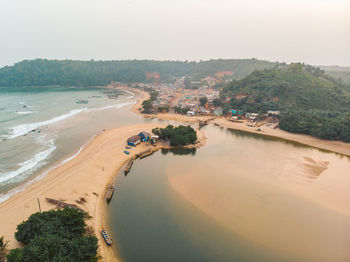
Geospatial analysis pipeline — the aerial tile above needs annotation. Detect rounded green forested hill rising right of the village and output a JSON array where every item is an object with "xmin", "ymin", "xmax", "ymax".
[{"xmin": 220, "ymin": 64, "xmax": 350, "ymax": 142}]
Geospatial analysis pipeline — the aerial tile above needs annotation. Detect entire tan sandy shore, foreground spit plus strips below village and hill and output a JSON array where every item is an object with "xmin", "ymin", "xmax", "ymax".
[{"xmin": 0, "ymin": 86, "xmax": 350, "ymax": 261}]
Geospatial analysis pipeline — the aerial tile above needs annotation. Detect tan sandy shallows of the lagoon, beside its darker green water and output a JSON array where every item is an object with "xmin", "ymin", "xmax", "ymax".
[{"xmin": 166, "ymin": 127, "xmax": 350, "ymax": 261}]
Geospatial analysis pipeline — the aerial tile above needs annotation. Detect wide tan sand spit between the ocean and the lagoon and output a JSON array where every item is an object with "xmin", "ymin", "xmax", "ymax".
[{"xmin": 0, "ymin": 124, "xmax": 164, "ymax": 261}]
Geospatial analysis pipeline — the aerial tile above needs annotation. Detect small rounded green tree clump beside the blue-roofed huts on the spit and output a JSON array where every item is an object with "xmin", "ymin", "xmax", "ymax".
[{"xmin": 152, "ymin": 125, "xmax": 197, "ymax": 146}]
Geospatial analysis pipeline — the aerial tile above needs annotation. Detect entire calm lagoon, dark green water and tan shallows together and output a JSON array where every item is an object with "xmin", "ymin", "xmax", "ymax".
[{"xmin": 109, "ymin": 126, "xmax": 350, "ymax": 262}]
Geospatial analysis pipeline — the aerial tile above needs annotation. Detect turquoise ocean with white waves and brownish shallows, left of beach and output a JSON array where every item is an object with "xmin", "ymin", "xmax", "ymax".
[{"xmin": 0, "ymin": 87, "xmax": 138, "ymax": 202}]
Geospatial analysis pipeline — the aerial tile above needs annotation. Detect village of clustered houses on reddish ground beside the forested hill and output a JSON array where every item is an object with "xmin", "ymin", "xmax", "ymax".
[{"xmin": 127, "ymin": 73, "xmax": 280, "ymax": 128}]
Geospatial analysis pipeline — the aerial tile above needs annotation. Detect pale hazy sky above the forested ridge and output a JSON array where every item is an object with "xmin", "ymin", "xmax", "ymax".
[{"xmin": 0, "ymin": 0, "xmax": 350, "ymax": 66}]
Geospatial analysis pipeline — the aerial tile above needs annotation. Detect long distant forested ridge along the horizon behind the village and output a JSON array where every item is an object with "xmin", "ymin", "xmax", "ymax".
[{"xmin": 0, "ymin": 59, "xmax": 276, "ymax": 87}]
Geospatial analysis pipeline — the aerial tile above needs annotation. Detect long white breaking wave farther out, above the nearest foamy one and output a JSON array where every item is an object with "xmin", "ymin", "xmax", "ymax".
[{"xmin": 6, "ymin": 108, "xmax": 88, "ymax": 139}]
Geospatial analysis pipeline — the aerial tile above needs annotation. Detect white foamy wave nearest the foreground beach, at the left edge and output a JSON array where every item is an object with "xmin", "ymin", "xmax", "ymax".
[{"xmin": 0, "ymin": 140, "xmax": 56, "ymax": 183}]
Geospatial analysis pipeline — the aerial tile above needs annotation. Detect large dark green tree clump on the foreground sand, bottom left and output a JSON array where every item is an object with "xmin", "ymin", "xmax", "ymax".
[{"xmin": 7, "ymin": 208, "xmax": 98, "ymax": 262}]
